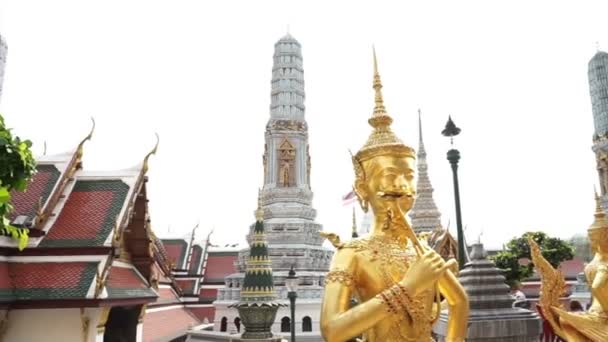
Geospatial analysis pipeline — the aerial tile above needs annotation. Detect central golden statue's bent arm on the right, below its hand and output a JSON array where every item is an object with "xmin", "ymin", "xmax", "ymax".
[{"xmin": 439, "ymin": 270, "xmax": 469, "ymax": 342}]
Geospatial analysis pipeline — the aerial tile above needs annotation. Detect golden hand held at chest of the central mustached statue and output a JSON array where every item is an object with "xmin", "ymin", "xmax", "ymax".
[{"xmin": 400, "ymin": 250, "xmax": 456, "ymax": 296}]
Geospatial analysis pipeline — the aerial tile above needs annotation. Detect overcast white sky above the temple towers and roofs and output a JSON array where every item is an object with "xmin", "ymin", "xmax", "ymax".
[{"xmin": 0, "ymin": 0, "xmax": 608, "ymax": 247}]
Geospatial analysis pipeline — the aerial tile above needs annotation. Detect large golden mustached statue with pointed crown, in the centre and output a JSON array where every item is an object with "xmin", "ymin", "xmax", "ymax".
[{"xmin": 321, "ymin": 52, "xmax": 469, "ymax": 342}]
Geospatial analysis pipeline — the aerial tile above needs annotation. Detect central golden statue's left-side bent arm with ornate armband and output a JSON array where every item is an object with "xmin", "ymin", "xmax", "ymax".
[{"xmin": 321, "ymin": 248, "xmax": 388, "ymax": 342}]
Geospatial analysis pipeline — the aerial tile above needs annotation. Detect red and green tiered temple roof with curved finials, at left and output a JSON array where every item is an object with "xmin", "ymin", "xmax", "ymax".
[{"xmin": 0, "ymin": 130, "xmax": 162, "ymax": 308}]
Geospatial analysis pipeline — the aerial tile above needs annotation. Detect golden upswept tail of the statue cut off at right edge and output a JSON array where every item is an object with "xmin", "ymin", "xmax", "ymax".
[{"xmin": 528, "ymin": 237, "xmax": 566, "ymax": 338}]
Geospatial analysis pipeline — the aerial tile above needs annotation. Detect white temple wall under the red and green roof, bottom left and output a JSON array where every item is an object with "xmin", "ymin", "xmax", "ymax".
[{"xmin": 2, "ymin": 308, "xmax": 100, "ymax": 342}]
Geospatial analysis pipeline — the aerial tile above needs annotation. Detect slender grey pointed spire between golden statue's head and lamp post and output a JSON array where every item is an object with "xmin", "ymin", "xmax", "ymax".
[{"xmin": 409, "ymin": 109, "xmax": 441, "ymax": 233}]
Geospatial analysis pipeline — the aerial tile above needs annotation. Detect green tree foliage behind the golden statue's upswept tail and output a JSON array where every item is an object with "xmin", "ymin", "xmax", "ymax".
[{"xmin": 492, "ymin": 232, "xmax": 574, "ymax": 285}]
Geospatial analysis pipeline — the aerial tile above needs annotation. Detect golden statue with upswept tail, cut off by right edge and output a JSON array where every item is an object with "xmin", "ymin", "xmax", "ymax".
[{"xmin": 528, "ymin": 193, "xmax": 608, "ymax": 342}]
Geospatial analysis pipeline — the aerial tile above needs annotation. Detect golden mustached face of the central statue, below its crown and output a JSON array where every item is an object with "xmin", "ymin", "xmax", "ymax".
[{"xmin": 356, "ymin": 156, "xmax": 416, "ymax": 215}]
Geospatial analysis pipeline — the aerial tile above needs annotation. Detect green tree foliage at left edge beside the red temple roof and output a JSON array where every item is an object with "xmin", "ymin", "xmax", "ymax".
[{"xmin": 0, "ymin": 115, "xmax": 36, "ymax": 250}]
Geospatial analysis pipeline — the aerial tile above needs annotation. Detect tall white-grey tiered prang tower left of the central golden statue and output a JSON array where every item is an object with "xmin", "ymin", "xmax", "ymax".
[{"xmin": 214, "ymin": 34, "xmax": 333, "ymax": 341}]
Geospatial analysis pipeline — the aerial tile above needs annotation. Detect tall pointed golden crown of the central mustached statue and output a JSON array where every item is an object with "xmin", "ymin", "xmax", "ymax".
[{"xmin": 353, "ymin": 49, "xmax": 415, "ymax": 164}]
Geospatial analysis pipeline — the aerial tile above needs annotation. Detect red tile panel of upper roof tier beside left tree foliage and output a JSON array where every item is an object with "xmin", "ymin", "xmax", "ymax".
[{"xmin": 10, "ymin": 165, "xmax": 60, "ymax": 219}]
